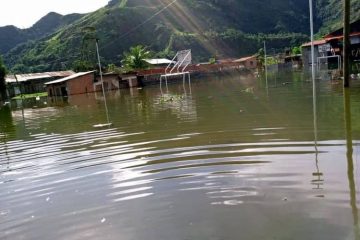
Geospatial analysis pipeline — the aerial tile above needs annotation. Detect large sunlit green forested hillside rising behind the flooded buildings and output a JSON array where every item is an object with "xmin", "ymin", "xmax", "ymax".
[{"xmin": 0, "ymin": 0, "xmax": 360, "ymax": 72}]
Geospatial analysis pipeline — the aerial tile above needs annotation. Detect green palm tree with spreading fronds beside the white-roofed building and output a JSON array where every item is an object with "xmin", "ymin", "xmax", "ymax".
[{"xmin": 121, "ymin": 45, "xmax": 151, "ymax": 71}]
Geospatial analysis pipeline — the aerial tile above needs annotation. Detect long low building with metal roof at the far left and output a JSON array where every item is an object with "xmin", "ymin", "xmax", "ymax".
[{"xmin": 5, "ymin": 71, "xmax": 74, "ymax": 97}]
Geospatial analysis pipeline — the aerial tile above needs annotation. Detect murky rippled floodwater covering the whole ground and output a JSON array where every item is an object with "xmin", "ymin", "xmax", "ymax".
[{"xmin": 0, "ymin": 72, "xmax": 360, "ymax": 240}]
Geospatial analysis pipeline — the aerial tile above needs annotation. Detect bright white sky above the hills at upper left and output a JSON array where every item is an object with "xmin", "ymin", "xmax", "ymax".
[{"xmin": 0, "ymin": 0, "xmax": 109, "ymax": 28}]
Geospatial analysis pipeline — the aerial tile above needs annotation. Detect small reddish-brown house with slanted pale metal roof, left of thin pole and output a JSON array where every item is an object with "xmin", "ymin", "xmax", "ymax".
[{"xmin": 45, "ymin": 71, "xmax": 95, "ymax": 97}]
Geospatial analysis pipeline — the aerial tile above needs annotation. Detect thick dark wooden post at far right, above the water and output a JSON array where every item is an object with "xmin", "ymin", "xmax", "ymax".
[{"xmin": 343, "ymin": 0, "xmax": 350, "ymax": 88}]
